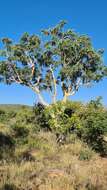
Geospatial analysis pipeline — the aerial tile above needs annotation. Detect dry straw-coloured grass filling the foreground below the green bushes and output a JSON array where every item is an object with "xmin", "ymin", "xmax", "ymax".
[{"xmin": 0, "ymin": 132, "xmax": 107, "ymax": 190}]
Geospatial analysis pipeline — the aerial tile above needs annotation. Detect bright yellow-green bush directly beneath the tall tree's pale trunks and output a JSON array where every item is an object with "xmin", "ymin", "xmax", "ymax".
[{"xmin": 44, "ymin": 102, "xmax": 81, "ymax": 134}]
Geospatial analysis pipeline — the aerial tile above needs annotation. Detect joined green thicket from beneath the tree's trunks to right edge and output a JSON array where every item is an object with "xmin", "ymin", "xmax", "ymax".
[{"xmin": 42, "ymin": 97, "xmax": 107, "ymax": 155}]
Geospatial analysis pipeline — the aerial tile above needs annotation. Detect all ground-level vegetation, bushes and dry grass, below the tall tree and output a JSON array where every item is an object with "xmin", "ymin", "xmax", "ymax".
[{"xmin": 0, "ymin": 97, "xmax": 107, "ymax": 190}]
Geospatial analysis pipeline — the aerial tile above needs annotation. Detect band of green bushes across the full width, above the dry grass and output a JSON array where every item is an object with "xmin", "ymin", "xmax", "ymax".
[{"xmin": 0, "ymin": 97, "xmax": 107, "ymax": 159}]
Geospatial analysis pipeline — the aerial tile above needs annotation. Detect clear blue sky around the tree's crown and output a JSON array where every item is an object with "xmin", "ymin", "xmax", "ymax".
[{"xmin": 0, "ymin": 0, "xmax": 107, "ymax": 105}]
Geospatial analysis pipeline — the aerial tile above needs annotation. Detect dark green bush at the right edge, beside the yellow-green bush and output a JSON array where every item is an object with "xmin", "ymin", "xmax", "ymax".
[{"xmin": 81, "ymin": 98, "xmax": 107, "ymax": 155}]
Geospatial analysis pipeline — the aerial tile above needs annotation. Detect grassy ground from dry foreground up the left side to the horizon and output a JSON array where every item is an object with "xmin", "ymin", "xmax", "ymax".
[{"xmin": 0, "ymin": 105, "xmax": 107, "ymax": 190}]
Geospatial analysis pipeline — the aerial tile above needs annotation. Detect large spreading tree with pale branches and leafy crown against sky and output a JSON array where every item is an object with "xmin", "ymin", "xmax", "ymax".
[{"xmin": 0, "ymin": 21, "xmax": 107, "ymax": 106}]
